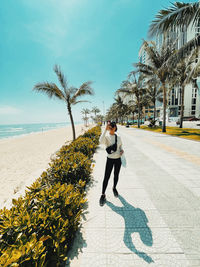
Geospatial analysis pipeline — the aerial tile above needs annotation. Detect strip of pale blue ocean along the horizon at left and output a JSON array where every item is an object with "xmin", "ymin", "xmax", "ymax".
[{"xmin": 0, "ymin": 122, "xmax": 80, "ymax": 139}]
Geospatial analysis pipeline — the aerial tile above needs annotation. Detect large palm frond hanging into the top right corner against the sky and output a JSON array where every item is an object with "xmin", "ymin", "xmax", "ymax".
[{"xmin": 149, "ymin": 2, "xmax": 200, "ymax": 37}]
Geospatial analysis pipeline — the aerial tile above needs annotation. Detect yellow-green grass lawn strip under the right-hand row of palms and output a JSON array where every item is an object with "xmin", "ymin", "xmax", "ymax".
[{"xmin": 131, "ymin": 125, "xmax": 200, "ymax": 141}]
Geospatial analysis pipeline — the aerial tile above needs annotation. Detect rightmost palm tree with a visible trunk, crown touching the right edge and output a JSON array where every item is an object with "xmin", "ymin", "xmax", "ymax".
[{"xmin": 170, "ymin": 48, "xmax": 200, "ymax": 128}]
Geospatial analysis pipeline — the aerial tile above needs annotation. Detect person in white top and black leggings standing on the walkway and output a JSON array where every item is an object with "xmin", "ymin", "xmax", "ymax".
[{"xmin": 99, "ymin": 121, "xmax": 124, "ymax": 206}]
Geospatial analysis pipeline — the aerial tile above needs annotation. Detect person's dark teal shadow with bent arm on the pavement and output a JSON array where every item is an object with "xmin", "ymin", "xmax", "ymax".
[{"xmin": 106, "ymin": 195, "xmax": 154, "ymax": 263}]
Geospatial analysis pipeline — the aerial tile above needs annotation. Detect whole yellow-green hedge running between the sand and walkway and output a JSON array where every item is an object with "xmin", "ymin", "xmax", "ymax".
[{"xmin": 0, "ymin": 127, "xmax": 101, "ymax": 267}]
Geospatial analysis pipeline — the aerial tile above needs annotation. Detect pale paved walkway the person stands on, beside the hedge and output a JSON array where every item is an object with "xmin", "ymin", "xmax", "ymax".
[{"xmin": 69, "ymin": 127, "xmax": 200, "ymax": 267}]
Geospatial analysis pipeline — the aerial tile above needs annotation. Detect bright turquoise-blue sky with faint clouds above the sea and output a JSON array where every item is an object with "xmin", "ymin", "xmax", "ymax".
[{"xmin": 0, "ymin": 0, "xmax": 195, "ymax": 124}]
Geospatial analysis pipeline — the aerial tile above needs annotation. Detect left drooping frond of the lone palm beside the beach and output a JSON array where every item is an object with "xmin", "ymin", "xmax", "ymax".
[{"xmin": 33, "ymin": 82, "xmax": 65, "ymax": 100}]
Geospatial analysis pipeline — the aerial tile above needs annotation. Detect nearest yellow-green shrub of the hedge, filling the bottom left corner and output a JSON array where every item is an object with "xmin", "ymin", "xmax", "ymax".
[{"xmin": 0, "ymin": 181, "xmax": 85, "ymax": 266}]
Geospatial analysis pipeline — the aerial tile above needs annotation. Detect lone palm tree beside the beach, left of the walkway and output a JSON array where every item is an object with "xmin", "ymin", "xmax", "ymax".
[{"xmin": 33, "ymin": 65, "xmax": 93, "ymax": 140}]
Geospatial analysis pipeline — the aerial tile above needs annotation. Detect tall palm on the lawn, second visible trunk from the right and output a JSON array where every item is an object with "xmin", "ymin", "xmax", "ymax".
[{"xmin": 134, "ymin": 41, "xmax": 175, "ymax": 132}]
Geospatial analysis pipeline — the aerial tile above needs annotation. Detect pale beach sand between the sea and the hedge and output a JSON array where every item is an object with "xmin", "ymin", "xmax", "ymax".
[{"xmin": 0, "ymin": 125, "xmax": 86, "ymax": 209}]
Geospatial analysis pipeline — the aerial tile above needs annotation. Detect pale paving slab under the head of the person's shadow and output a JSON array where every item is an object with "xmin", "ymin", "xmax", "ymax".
[{"xmin": 106, "ymin": 227, "xmax": 183, "ymax": 254}]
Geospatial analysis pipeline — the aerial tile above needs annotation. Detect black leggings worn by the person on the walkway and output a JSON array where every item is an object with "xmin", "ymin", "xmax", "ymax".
[{"xmin": 102, "ymin": 158, "xmax": 122, "ymax": 194}]
